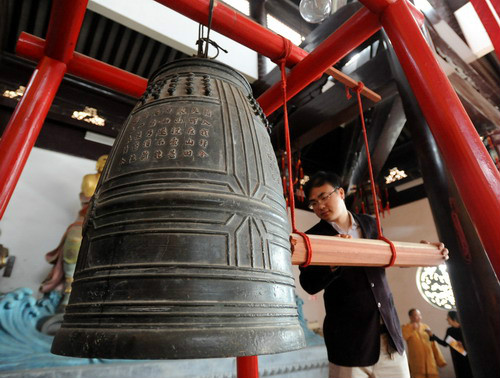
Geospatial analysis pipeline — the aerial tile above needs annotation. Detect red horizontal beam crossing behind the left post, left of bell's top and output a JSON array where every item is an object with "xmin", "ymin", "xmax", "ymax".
[{"xmin": 16, "ymin": 32, "xmax": 148, "ymax": 97}]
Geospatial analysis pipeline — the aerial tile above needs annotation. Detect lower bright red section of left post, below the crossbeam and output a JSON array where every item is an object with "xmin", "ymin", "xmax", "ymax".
[{"xmin": 0, "ymin": 57, "xmax": 66, "ymax": 218}]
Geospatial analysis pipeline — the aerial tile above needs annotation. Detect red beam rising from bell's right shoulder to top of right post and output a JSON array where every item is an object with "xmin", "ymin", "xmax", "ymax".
[{"xmin": 257, "ymin": 7, "xmax": 380, "ymax": 116}]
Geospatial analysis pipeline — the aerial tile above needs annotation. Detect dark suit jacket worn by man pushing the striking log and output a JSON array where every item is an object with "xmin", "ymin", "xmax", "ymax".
[{"xmin": 300, "ymin": 214, "xmax": 404, "ymax": 366}]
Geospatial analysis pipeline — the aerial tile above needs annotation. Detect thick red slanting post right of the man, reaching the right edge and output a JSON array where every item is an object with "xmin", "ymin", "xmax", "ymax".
[{"xmin": 376, "ymin": 0, "xmax": 500, "ymax": 277}]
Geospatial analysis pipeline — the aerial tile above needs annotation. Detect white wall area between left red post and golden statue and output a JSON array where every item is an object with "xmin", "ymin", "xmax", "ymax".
[{"xmin": 0, "ymin": 148, "xmax": 95, "ymax": 294}]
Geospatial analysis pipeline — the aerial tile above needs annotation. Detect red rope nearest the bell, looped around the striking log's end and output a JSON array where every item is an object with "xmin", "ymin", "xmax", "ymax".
[{"xmin": 275, "ymin": 36, "xmax": 312, "ymax": 268}]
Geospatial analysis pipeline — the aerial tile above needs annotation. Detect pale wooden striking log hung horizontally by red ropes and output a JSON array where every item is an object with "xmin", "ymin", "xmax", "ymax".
[{"xmin": 290, "ymin": 234, "xmax": 444, "ymax": 267}]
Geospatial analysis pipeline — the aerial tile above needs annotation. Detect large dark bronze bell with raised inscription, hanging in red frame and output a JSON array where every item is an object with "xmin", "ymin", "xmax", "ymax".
[{"xmin": 52, "ymin": 58, "xmax": 305, "ymax": 359}]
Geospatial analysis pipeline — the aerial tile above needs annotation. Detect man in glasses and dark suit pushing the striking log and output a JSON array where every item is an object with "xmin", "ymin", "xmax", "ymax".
[{"xmin": 300, "ymin": 172, "xmax": 410, "ymax": 378}]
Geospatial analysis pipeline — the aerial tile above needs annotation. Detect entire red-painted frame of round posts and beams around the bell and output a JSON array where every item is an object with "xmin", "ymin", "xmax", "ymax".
[{"xmin": 0, "ymin": 0, "xmax": 500, "ymax": 378}]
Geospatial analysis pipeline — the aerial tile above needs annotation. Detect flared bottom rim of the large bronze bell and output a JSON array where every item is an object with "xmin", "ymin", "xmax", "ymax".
[{"xmin": 51, "ymin": 323, "xmax": 307, "ymax": 360}]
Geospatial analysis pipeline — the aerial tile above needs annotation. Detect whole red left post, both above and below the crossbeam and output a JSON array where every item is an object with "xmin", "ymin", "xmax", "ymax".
[{"xmin": 0, "ymin": 0, "xmax": 88, "ymax": 219}]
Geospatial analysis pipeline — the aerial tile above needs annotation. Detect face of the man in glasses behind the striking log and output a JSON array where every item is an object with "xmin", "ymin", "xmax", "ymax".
[{"xmin": 309, "ymin": 184, "xmax": 347, "ymax": 222}]
